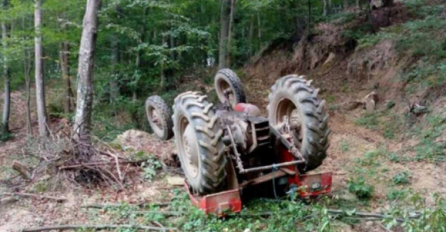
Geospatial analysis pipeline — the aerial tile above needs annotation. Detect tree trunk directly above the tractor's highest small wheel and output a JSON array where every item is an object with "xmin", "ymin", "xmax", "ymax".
[{"xmin": 218, "ymin": 0, "xmax": 231, "ymax": 69}]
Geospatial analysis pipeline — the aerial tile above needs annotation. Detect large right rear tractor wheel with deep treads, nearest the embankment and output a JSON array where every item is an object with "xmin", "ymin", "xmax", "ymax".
[{"xmin": 268, "ymin": 75, "xmax": 330, "ymax": 172}]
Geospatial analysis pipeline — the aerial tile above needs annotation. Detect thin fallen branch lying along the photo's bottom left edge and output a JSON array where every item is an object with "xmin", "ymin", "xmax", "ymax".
[{"xmin": 21, "ymin": 225, "xmax": 178, "ymax": 232}]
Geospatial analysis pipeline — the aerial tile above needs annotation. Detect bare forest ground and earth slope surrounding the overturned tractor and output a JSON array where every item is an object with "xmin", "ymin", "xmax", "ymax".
[{"xmin": 0, "ymin": 0, "xmax": 446, "ymax": 232}]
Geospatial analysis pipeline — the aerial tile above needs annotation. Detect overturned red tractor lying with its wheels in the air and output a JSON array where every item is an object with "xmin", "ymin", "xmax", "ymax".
[{"xmin": 145, "ymin": 69, "xmax": 332, "ymax": 215}]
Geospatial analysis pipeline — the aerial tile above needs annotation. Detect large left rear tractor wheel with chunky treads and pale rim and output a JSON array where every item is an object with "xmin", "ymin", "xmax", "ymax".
[{"xmin": 172, "ymin": 92, "xmax": 226, "ymax": 194}]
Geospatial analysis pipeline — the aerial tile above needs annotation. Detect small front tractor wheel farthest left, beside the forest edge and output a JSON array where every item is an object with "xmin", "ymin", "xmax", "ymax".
[{"xmin": 146, "ymin": 96, "xmax": 173, "ymax": 140}]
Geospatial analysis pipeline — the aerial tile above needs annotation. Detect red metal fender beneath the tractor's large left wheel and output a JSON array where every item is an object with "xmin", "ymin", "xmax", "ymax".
[{"xmin": 185, "ymin": 183, "xmax": 242, "ymax": 216}]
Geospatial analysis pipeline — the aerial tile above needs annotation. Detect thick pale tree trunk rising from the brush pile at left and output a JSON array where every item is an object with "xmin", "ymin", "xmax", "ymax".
[{"xmin": 73, "ymin": 0, "xmax": 101, "ymax": 143}]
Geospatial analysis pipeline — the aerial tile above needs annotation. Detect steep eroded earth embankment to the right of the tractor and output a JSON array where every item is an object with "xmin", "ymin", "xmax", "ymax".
[{"xmin": 244, "ymin": 1, "xmax": 446, "ymax": 215}]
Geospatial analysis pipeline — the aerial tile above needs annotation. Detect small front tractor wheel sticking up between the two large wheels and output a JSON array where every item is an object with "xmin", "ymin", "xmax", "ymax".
[{"xmin": 214, "ymin": 68, "xmax": 246, "ymax": 107}]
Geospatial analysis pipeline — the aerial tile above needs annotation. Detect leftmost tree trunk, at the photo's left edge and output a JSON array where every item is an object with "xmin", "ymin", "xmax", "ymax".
[{"xmin": 0, "ymin": 0, "xmax": 11, "ymax": 135}]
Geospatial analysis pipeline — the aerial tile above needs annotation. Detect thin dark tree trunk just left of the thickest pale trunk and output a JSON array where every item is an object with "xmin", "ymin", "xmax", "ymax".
[{"xmin": 60, "ymin": 42, "xmax": 73, "ymax": 114}]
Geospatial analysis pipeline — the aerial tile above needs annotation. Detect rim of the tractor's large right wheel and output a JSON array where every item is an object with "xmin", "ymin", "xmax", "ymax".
[{"xmin": 275, "ymin": 98, "xmax": 303, "ymax": 147}]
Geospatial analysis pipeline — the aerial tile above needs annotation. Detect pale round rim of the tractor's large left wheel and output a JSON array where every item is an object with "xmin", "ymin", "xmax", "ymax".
[{"xmin": 180, "ymin": 117, "xmax": 200, "ymax": 177}]
